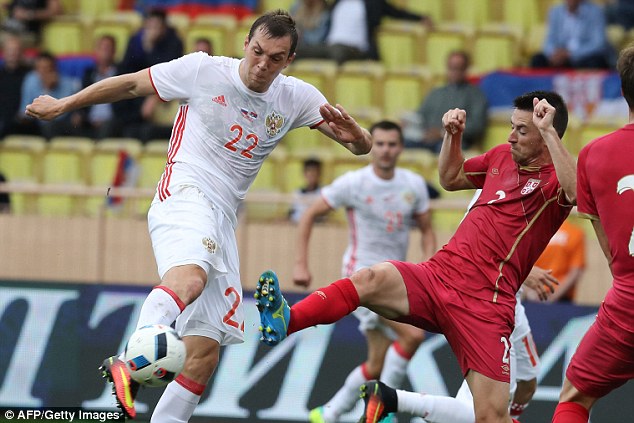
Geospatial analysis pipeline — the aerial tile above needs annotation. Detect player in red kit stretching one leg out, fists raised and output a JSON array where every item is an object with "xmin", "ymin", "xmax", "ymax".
[{"xmin": 256, "ymin": 91, "xmax": 576, "ymax": 423}]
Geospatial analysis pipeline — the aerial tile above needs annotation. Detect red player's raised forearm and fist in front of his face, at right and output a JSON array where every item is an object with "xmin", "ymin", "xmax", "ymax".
[{"xmin": 533, "ymin": 98, "xmax": 577, "ymax": 204}]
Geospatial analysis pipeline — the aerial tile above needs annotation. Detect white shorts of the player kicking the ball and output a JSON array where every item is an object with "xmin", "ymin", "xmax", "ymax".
[{"xmin": 148, "ymin": 185, "xmax": 244, "ymax": 345}]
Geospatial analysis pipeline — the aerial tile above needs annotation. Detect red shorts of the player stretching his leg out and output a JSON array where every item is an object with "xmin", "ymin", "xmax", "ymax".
[{"xmin": 390, "ymin": 261, "xmax": 515, "ymax": 383}]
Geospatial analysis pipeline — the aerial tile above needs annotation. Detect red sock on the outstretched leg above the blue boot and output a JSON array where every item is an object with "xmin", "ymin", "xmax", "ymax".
[{"xmin": 288, "ymin": 278, "xmax": 359, "ymax": 335}]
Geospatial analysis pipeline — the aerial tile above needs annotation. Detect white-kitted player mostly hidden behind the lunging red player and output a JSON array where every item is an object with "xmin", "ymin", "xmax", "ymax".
[{"xmin": 360, "ymin": 189, "xmax": 559, "ymax": 423}]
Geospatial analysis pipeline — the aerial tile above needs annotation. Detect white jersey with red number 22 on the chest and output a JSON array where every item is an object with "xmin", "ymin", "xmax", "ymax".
[{"xmin": 150, "ymin": 52, "xmax": 327, "ymax": 227}]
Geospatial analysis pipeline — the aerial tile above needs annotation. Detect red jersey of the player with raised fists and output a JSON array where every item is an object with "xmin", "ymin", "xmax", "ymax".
[{"xmin": 429, "ymin": 144, "xmax": 572, "ymax": 307}]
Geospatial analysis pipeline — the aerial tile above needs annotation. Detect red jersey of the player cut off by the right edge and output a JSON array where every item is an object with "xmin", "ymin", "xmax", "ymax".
[{"xmin": 577, "ymin": 124, "xmax": 634, "ymax": 331}]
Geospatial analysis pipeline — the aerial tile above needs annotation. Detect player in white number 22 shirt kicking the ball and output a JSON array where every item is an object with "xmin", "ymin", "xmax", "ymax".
[{"xmin": 26, "ymin": 10, "xmax": 371, "ymax": 423}]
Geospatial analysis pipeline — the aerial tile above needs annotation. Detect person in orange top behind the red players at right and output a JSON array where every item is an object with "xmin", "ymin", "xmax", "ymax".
[{"xmin": 525, "ymin": 220, "xmax": 586, "ymax": 302}]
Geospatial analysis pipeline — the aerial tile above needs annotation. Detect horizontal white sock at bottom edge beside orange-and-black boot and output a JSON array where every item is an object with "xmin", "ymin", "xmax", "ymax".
[{"xmin": 396, "ymin": 390, "xmax": 475, "ymax": 423}]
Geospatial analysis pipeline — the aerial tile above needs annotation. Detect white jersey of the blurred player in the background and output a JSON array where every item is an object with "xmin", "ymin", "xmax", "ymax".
[{"xmin": 321, "ymin": 165, "xmax": 429, "ymax": 276}]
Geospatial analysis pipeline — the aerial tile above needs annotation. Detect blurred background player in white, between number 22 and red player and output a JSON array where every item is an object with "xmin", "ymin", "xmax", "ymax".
[{"xmin": 286, "ymin": 121, "xmax": 436, "ymax": 423}]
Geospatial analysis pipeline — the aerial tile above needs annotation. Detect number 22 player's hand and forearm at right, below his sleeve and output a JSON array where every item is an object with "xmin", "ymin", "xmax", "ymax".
[{"xmin": 317, "ymin": 104, "xmax": 372, "ymax": 155}]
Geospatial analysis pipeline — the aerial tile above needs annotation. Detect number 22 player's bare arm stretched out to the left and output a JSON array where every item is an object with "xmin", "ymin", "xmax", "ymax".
[{"xmin": 26, "ymin": 69, "xmax": 154, "ymax": 120}]
